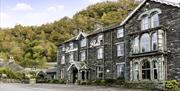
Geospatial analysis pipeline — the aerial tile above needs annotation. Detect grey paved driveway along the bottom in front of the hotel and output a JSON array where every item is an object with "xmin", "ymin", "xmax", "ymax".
[{"xmin": 0, "ymin": 83, "xmax": 146, "ymax": 91}]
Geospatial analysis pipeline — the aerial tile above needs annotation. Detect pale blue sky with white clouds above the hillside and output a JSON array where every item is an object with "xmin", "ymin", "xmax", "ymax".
[{"xmin": 0, "ymin": 0, "xmax": 180, "ymax": 28}]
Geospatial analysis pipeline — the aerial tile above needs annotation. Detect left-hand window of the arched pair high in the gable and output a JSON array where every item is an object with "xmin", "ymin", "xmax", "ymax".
[{"xmin": 141, "ymin": 16, "xmax": 150, "ymax": 30}]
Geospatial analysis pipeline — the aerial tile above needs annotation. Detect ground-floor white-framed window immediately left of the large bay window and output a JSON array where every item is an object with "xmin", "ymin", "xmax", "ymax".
[{"xmin": 116, "ymin": 63, "xmax": 125, "ymax": 78}]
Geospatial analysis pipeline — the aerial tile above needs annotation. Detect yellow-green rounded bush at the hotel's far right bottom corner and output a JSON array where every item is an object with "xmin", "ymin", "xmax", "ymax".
[{"xmin": 165, "ymin": 80, "xmax": 178, "ymax": 90}]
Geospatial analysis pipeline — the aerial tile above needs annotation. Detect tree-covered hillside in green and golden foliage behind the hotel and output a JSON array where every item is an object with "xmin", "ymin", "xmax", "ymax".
[{"xmin": 0, "ymin": 0, "xmax": 137, "ymax": 68}]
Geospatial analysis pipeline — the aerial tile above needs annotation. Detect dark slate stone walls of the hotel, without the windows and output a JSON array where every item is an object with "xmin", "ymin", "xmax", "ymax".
[{"xmin": 57, "ymin": 0, "xmax": 180, "ymax": 82}]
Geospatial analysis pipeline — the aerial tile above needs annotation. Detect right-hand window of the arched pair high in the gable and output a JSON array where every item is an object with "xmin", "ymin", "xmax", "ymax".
[{"xmin": 151, "ymin": 12, "xmax": 159, "ymax": 28}]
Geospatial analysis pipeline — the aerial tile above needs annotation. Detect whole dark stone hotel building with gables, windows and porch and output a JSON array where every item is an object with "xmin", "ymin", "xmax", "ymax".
[{"xmin": 57, "ymin": 0, "xmax": 180, "ymax": 82}]
